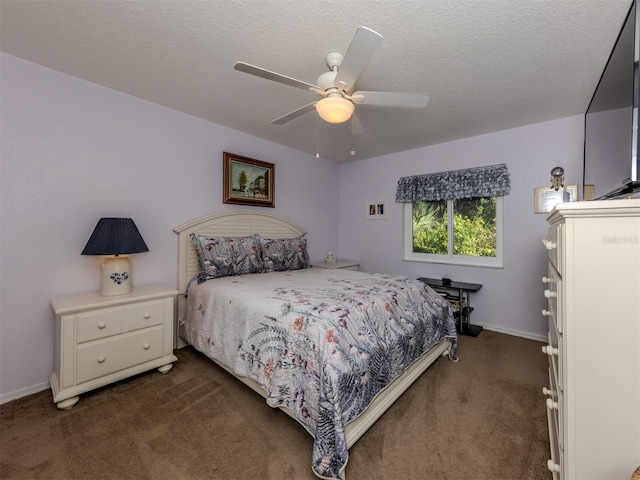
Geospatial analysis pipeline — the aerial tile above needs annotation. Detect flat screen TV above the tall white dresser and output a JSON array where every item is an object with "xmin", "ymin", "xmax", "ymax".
[{"xmin": 583, "ymin": 1, "xmax": 640, "ymax": 199}]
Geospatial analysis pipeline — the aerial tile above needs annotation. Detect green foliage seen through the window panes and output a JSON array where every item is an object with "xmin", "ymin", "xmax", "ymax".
[{"xmin": 413, "ymin": 197, "xmax": 497, "ymax": 257}]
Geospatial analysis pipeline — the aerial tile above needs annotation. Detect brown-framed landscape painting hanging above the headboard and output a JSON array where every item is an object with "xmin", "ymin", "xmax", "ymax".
[{"xmin": 222, "ymin": 152, "xmax": 275, "ymax": 207}]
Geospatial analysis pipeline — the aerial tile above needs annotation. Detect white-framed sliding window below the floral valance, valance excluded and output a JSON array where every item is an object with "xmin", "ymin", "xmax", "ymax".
[{"xmin": 404, "ymin": 196, "xmax": 503, "ymax": 268}]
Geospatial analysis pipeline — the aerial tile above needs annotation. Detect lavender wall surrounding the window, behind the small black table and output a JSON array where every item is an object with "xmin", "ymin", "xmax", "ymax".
[{"xmin": 340, "ymin": 116, "xmax": 584, "ymax": 339}]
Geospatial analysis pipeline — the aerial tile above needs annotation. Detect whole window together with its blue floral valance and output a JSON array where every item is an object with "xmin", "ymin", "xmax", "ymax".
[{"xmin": 396, "ymin": 163, "xmax": 511, "ymax": 268}]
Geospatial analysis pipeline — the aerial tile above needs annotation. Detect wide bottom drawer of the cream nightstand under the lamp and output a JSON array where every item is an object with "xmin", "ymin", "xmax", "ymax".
[{"xmin": 76, "ymin": 326, "xmax": 164, "ymax": 383}]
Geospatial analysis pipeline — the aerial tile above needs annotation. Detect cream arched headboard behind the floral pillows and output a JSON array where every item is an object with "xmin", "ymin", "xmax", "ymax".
[{"xmin": 173, "ymin": 210, "xmax": 306, "ymax": 346}]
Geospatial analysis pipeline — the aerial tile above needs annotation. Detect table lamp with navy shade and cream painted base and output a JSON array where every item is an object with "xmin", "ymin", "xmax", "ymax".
[{"xmin": 82, "ymin": 218, "xmax": 149, "ymax": 296}]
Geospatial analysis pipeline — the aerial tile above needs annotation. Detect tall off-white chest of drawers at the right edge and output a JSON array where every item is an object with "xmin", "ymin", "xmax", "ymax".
[{"xmin": 542, "ymin": 200, "xmax": 640, "ymax": 480}]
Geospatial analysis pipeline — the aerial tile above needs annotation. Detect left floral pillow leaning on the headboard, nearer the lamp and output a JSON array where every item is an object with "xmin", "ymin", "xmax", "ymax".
[{"xmin": 190, "ymin": 233, "xmax": 264, "ymax": 283}]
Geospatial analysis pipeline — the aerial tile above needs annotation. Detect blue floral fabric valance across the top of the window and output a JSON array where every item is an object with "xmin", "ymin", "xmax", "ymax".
[{"xmin": 396, "ymin": 163, "xmax": 511, "ymax": 203}]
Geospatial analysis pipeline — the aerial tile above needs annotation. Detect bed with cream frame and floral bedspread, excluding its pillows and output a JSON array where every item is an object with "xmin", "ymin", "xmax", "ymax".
[{"xmin": 174, "ymin": 210, "xmax": 457, "ymax": 479}]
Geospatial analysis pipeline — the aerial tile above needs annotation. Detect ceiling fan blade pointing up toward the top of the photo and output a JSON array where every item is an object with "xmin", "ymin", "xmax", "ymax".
[{"xmin": 335, "ymin": 27, "xmax": 382, "ymax": 92}]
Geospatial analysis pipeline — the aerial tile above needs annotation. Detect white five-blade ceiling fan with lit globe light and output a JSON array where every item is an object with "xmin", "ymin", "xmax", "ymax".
[{"xmin": 234, "ymin": 27, "xmax": 429, "ymax": 136}]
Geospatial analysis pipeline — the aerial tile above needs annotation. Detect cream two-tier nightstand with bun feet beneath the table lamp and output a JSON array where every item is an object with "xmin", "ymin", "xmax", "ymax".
[{"xmin": 49, "ymin": 285, "xmax": 178, "ymax": 410}]
